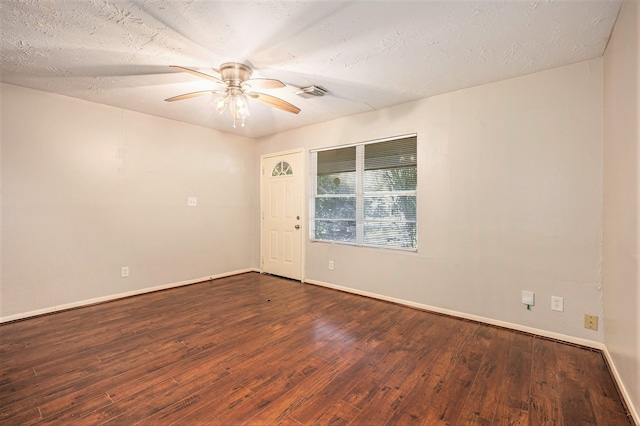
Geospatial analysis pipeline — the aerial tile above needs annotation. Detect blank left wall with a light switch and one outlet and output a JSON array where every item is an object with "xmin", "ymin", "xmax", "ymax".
[{"xmin": 0, "ymin": 85, "xmax": 258, "ymax": 318}]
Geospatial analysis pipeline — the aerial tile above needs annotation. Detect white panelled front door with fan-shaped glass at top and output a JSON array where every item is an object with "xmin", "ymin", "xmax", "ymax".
[{"xmin": 260, "ymin": 150, "xmax": 305, "ymax": 280}]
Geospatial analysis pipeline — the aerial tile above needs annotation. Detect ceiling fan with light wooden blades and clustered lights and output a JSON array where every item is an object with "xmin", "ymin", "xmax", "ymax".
[{"xmin": 165, "ymin": 62, "xmax": 300, "ymax": 128}]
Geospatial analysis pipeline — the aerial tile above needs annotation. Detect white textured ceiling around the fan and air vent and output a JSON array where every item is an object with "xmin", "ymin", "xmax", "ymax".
[{"xmin": 0, "ymin": 0, "xmax": 620, "ymax": 137}]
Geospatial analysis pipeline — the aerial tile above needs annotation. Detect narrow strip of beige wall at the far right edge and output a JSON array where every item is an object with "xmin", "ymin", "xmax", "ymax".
[{"xmin": 603, "ymin": 1, "xmax": 640, "ymax": 420}]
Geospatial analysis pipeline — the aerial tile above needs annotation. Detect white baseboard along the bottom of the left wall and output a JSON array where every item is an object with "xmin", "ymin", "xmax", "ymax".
[{"xmin": 0, "ymin": 268, "xmax": 260, "ymax": 324}]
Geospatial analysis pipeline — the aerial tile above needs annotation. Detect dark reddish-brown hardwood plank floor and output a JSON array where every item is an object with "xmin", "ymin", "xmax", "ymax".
[{"xmin": 0, "ymin": 273, "xmax": 632, "ymax": 426}]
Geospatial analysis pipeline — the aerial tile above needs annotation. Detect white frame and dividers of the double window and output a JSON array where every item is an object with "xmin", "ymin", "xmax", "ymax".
[{"xmin": 309, "ymin": 133, "xmax": 418, "ymax": 252}]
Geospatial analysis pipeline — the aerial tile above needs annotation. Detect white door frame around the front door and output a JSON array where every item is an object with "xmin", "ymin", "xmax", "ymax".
[{"xmin": 259, "ymin": 148, "xmax": 309, "ymax": 282}]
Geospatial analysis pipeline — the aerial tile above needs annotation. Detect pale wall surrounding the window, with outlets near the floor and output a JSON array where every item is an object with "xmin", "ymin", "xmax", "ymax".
[{"xmin": 256, "ymin": 59, "xmax": 603, "ymax": 342}]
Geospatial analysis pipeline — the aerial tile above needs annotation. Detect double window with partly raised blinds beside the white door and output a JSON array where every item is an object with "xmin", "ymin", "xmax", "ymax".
[{"xmin": 310, "ymin": 135, "xmax": 418, "ymax": 250}]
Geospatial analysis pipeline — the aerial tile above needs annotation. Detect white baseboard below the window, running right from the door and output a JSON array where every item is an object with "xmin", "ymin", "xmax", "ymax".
[{"xmin": 305, "ymin": 280, "xmax": 604, "ymax": 349}]
